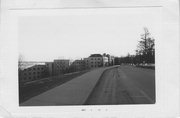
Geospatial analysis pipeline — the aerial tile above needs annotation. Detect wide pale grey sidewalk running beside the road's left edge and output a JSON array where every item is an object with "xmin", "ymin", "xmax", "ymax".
[{"xmin": 20, "ymin": 67, "xmax": 116, "ymax": 106}]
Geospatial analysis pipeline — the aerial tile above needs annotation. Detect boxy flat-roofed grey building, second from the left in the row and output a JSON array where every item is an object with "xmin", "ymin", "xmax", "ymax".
[{"xmin": 52, "ymin": 59, "xmax": 70, "ymax": 75}]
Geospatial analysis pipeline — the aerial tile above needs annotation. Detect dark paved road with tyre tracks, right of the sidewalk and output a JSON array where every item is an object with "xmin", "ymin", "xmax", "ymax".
[{"xmin": 85, "ymin": 66, "xmax": 155, "ymax": 105}]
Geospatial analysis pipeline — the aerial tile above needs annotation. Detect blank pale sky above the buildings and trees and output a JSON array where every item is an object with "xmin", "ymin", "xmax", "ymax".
[{"xmin": 18, "ymin": 8, "xmax": 161, "ymax": 61}]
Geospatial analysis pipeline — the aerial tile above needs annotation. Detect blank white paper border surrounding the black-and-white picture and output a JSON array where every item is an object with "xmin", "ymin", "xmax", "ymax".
[{"xmin": 0, "ymin": 0, "xmax": 179, "ymax": 118}]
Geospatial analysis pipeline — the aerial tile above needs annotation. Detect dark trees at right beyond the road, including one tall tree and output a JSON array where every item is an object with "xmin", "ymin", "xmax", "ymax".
[{"xmin": 115, "ymin": 27, "xmax": 155, "ymax": 65}]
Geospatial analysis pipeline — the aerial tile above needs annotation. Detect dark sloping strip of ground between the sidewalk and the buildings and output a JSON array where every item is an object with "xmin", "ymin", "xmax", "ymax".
[{"xmin": 19, "ymin": 71, "xmax": 87, "ymax": 103}]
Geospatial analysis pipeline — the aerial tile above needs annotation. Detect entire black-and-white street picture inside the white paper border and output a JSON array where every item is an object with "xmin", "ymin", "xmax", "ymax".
[{"xmin": 17, "ymin": 8, "xmax": 158, "ymax": 107}]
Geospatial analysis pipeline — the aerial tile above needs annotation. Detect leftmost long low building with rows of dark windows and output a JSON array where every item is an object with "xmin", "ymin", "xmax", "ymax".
[{"xmin": 19, "ymin": 64, "xmax": 48, "ymax": 82}]
